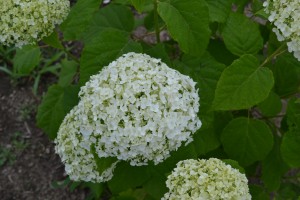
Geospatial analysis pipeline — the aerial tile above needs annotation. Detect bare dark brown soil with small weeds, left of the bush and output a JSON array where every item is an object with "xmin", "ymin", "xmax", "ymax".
[{"xmin": 0, "ymin": 73, "xmax": 87, "ymax": 200}]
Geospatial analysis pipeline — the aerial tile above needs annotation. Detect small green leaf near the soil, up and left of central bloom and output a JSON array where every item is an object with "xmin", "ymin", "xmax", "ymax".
[{"xmin": 58, "ymin": 60, "xmax": 78, "ymax": 87}]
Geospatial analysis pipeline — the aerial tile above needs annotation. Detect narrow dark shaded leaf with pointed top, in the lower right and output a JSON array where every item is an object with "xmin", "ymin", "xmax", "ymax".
[{"xmin": 261, "ymin": 137, "xmax": 289, "ymax": 191}]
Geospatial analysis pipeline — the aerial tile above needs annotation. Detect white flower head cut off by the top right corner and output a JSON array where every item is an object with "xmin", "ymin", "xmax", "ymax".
[{"xmin": 263, "ymin": 0, "xmax": 300, "ymax": 61}]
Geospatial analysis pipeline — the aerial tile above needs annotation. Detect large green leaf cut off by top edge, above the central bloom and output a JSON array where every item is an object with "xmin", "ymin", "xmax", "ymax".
[{"xmin": 158, "ymin": 0, "xmax": 210, "ymax": 56}]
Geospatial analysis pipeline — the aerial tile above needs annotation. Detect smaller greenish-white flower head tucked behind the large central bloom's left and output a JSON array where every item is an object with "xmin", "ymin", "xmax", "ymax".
[{"xmin": 55, "ymin": 106, "xmax": 117, "ymax": 182}]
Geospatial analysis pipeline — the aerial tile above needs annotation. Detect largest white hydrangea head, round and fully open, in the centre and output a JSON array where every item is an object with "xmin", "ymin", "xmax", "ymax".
[{"xmin": 78, "ymin": 53, "xmax": 201, "ymax": 166}]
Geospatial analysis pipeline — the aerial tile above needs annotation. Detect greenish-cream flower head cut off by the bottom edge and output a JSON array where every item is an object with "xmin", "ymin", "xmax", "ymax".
[{"xmin": 162, "ymin": 158, "xmax": 251, "ymax": 200}]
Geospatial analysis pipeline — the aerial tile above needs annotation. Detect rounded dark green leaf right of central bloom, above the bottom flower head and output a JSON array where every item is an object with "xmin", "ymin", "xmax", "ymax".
[{"xmin": 221, "ymin": 117, "xmax": 273, "ymax": 166}]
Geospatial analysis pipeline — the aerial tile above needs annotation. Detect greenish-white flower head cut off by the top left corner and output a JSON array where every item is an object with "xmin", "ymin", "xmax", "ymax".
[{"xmin": 0, "ymin": 0, "xmax": 70, "ymax": 47}]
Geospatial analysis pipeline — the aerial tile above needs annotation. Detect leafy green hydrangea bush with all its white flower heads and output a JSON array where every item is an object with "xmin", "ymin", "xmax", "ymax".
[{"xmin": 0, "ymin": 0, "xmax": 300, "ymax": 200}]
